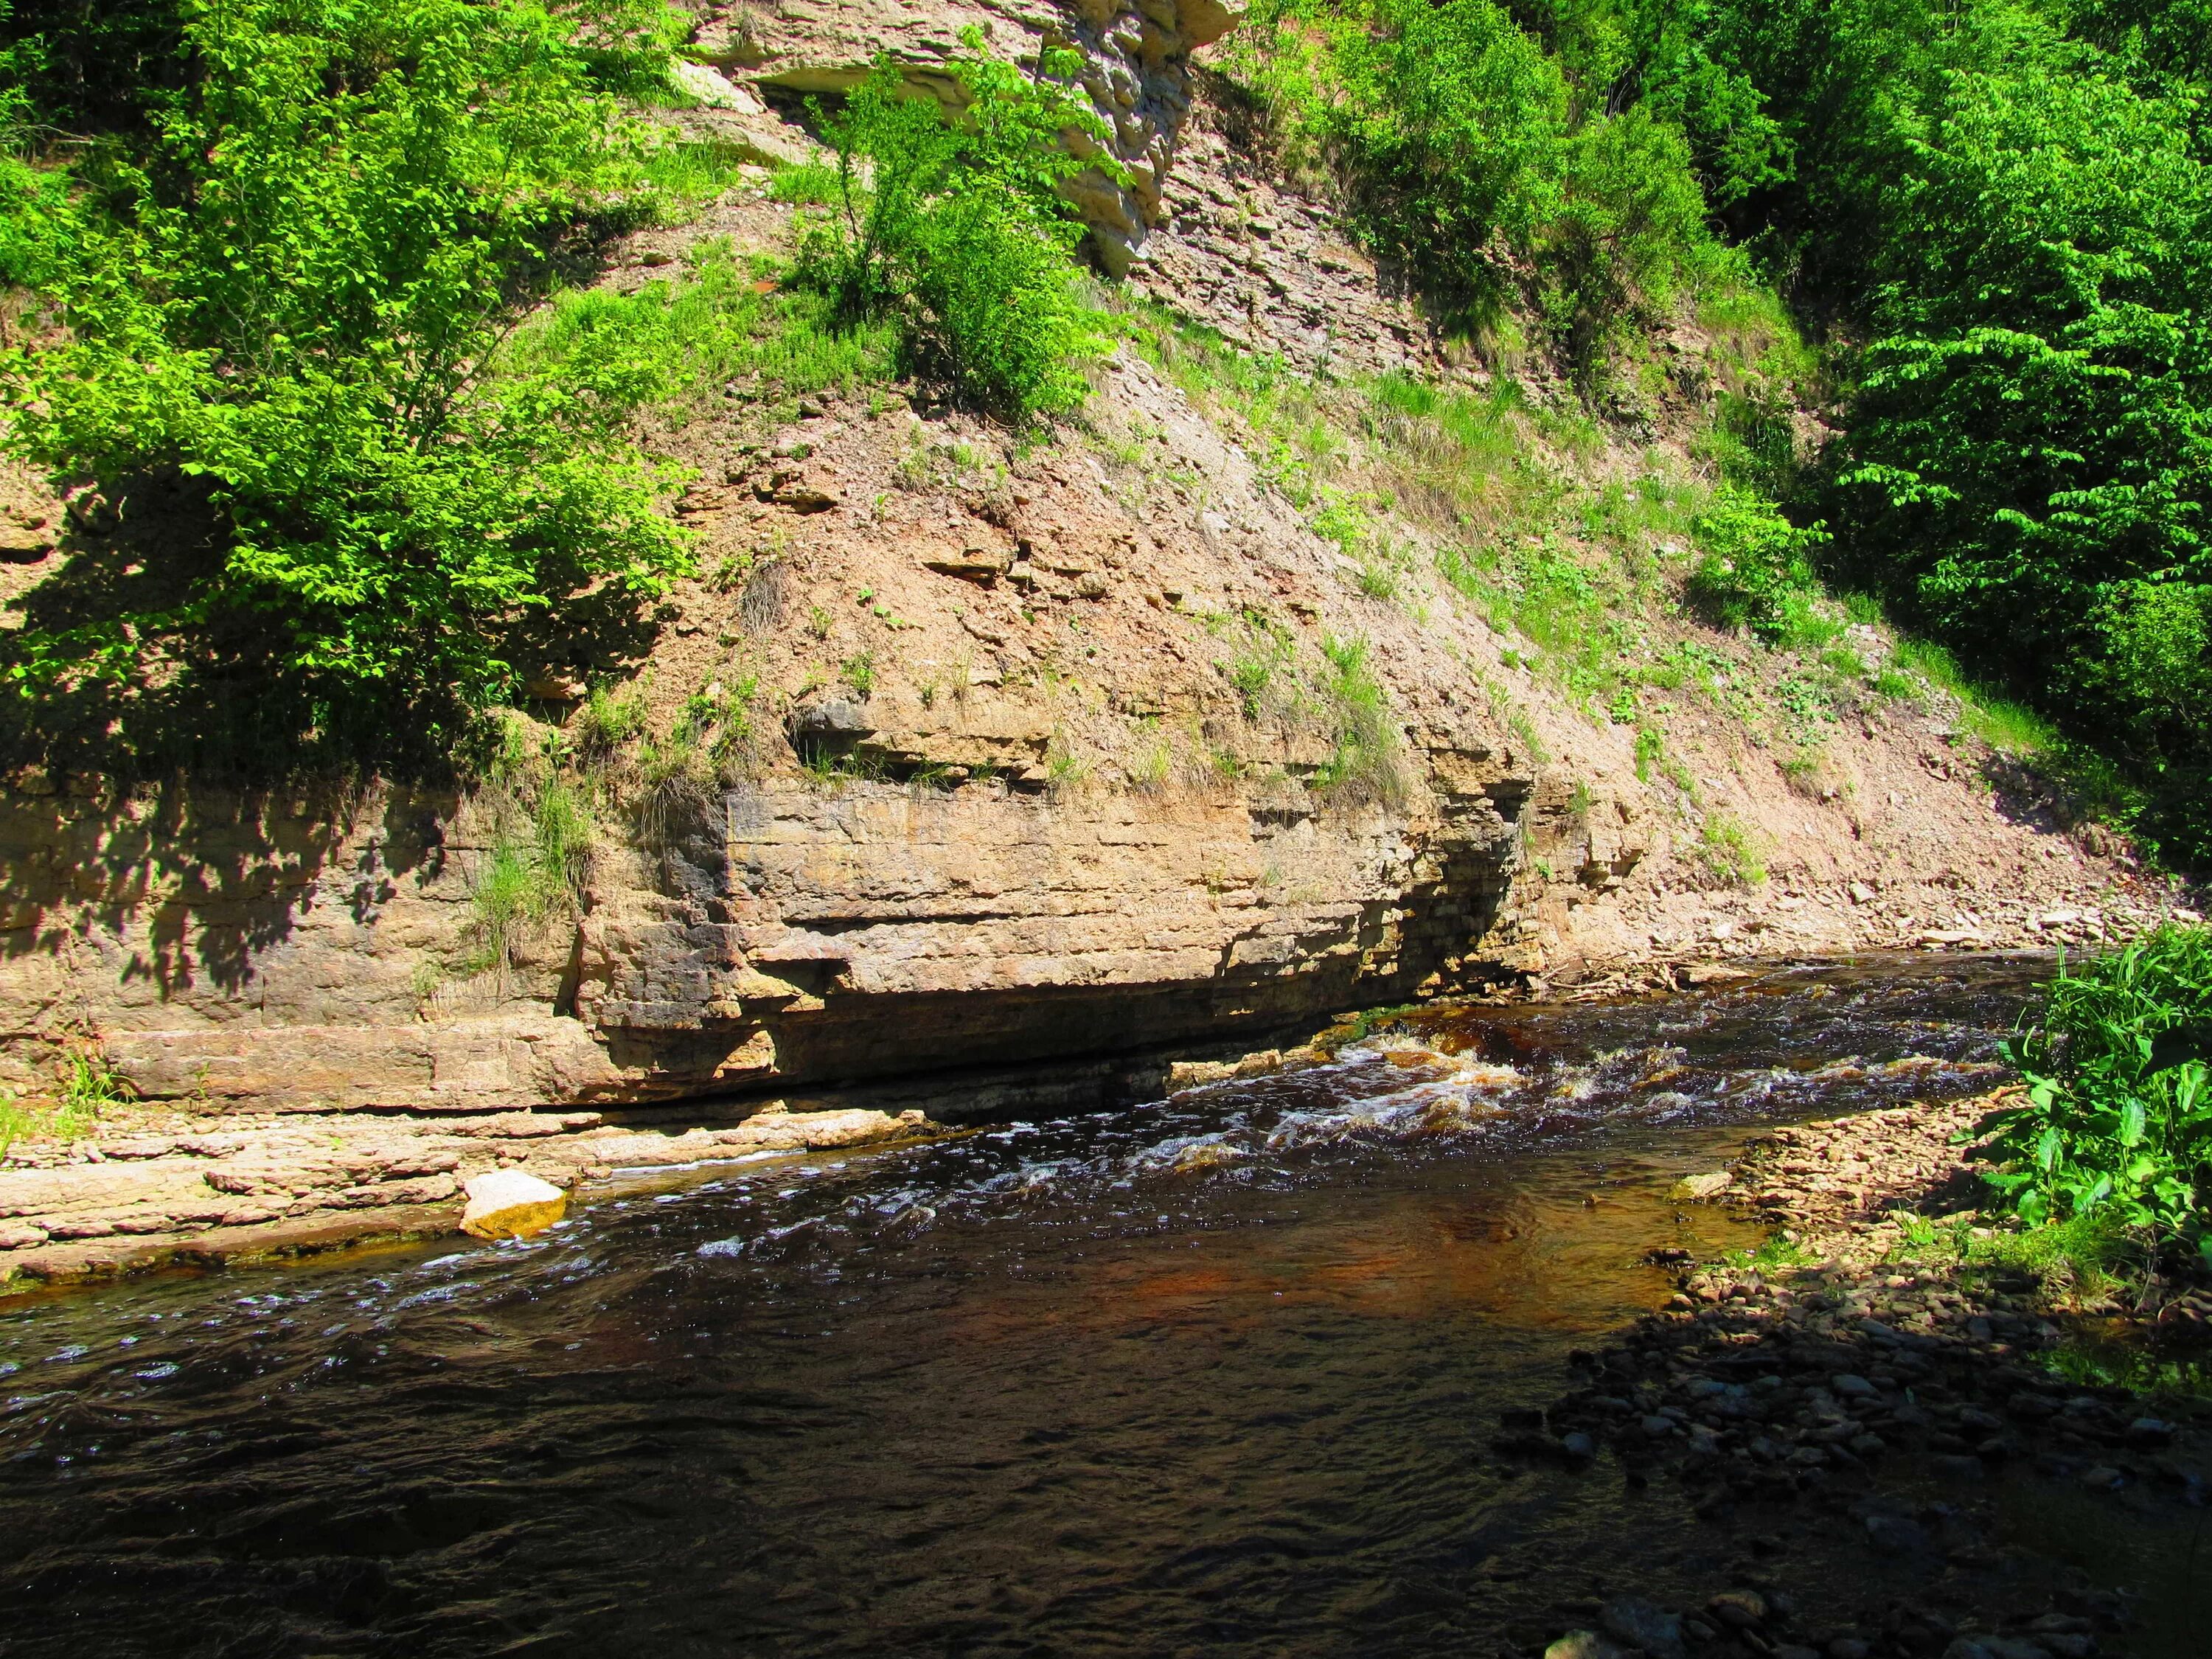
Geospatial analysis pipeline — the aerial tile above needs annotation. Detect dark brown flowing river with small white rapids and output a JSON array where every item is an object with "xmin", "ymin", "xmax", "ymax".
[{"xmin": 0, "ymin": 960, "xmax": 2194, "ymax": 1655}]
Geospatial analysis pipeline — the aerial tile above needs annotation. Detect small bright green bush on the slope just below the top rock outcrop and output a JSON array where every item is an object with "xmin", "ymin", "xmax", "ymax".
[{"xmin": 799, "ymin": 31, "xmax": 1113, "ymax": 422}]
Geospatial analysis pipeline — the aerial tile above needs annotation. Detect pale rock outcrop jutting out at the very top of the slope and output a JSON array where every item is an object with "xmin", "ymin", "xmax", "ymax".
[{"xmin": 699, "ymin": 0, "xmax": 1243, "ymax": 274}]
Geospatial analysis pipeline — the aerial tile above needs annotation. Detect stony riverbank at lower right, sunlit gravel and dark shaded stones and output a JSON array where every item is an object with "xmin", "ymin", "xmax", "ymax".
[{"xmin": 1493, "ymin": 1088, "xmax": 2212, "ymax": 1659}]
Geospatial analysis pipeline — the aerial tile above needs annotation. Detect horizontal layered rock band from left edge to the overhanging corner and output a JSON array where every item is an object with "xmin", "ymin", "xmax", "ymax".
[{"xmin": 0, "ymin": 734, "xmax": 1531, "ymax": 1113}]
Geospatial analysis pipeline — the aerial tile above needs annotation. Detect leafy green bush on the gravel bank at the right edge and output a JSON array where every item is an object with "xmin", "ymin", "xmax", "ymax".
[{"xmin": 1986, "ymin": 927, "xmax": 2212, "ymax": 1265}]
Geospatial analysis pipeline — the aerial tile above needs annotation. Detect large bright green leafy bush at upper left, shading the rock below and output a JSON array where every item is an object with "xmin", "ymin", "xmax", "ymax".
[{"xmin": 0, "ymin": 0, "xmax": 686, "ymax": 765}]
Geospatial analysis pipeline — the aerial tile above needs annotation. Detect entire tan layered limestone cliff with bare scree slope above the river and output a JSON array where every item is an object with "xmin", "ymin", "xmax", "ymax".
[{"xmin": 0, "ymin": 0, "xmax": 2168, "ymax": 1283}]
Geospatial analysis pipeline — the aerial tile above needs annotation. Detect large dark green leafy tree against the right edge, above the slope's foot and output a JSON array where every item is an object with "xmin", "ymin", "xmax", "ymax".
[{"xmin": 1836, "ymin": 38, "xmax": 2212, "ymax": 856}]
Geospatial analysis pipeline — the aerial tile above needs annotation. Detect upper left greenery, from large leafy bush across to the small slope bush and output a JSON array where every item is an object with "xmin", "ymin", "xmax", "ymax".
[{"xmin": 0, "ymin": 0, "xmax": 1097, "ymax": 787}]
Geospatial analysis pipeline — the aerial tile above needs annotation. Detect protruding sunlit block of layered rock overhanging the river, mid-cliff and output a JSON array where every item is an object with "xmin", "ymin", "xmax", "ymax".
[{"xmin": 575, "ymin": 763, "xmax": 1528, "ymax": 1086}]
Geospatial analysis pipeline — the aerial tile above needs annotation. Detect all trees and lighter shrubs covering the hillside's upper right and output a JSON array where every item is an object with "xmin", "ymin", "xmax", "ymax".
[{"xmin": 1225, "ymin": 0, "xmax": 2212, "ymax": 863}]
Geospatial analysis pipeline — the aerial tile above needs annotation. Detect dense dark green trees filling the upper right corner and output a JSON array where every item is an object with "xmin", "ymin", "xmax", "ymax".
[{"xmin": 1637, "ymin": 0, "xmax": 2212, "ymax": 863}]
